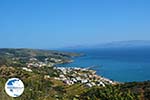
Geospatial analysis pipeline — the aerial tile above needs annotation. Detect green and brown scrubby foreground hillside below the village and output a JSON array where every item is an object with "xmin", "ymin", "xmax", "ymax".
[{"xmin": 0, "ymin": 66, "xmax": 150, "ymax": 100}]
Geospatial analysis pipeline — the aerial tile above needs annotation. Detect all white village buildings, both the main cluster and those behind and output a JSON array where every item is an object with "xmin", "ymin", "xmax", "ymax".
[{"xmin": 17, "ymin": 58, "xmax": 117, "ymax": 87}]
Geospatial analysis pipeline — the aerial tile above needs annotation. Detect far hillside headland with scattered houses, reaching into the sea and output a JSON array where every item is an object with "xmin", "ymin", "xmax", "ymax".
[{"xmin": 0, "ymin": 49, "xmax": 80, "ymax": 67}]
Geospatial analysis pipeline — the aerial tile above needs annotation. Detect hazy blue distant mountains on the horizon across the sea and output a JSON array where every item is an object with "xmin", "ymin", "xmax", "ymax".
[{"xmin": 64, "ymin": 40, "xmax": 150, "ymax": 50}]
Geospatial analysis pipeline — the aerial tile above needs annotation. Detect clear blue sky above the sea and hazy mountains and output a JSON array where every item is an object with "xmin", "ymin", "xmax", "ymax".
[{"xmin": 0, "ymin": 0, "xmax": 150, "ymax": 48}]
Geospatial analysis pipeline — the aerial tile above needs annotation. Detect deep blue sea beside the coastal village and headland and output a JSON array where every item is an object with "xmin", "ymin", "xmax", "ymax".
[{"xmin": 61, "ymin": 48, "xmax": 150, "ymax": 82}]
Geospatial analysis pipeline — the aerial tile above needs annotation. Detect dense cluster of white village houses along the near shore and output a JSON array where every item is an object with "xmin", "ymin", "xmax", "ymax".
[{"xmin": 54, "ymin": 67, "xmax": 117, "ymax": 87}]
